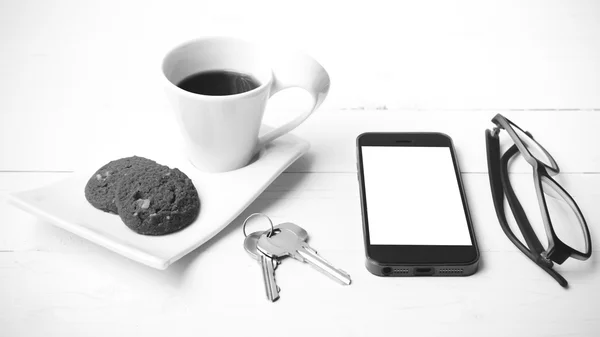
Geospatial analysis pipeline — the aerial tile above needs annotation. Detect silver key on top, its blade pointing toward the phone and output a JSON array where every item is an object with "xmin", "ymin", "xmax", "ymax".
[{"xmin": 256, "ymin": 227, "xmax": 352, "ymax": 285}]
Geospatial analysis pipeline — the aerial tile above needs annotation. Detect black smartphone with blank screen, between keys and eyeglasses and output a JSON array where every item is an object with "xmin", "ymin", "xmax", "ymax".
[{"xmin": 356, "ymin": 132, "xmax": 479, "ymax": 276}]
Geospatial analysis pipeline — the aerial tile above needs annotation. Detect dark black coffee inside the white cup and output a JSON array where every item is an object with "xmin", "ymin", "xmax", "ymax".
[{"xmin": 177, "ymin": 70, "xmax": 260, "ymax": 96}]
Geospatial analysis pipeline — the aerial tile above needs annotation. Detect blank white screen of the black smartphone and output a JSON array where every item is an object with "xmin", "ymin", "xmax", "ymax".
[{"xmin": 362, "ymin": 146, "xmax": 471, "ymax": 246}]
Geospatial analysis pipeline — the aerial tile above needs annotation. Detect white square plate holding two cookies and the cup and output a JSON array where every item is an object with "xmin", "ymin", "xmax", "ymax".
[{"xmin": 9, "ymin": 130, "xmax": 310, "ymax": 269}]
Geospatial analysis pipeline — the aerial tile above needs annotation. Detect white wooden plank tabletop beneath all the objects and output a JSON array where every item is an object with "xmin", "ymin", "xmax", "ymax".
[{"xmin": 0, "ymin": 1, "xmax": 600, "ymax": 336}]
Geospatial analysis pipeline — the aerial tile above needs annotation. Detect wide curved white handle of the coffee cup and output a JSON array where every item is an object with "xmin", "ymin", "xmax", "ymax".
[{"xmin": 257, "ymin": 53, "xmax": 330, "ymax": 150}]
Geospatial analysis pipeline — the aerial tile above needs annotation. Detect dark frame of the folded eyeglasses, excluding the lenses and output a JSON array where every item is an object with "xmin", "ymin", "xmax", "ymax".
[{"xmin": 486, "ymin": 114, "xmax": 592, "ymax": 287}]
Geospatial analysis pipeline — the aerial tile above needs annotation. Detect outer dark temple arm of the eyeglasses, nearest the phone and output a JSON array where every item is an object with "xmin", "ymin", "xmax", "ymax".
[{"xmin": 486, "ymin": 130, "xmax": 569, "ymax": 288}]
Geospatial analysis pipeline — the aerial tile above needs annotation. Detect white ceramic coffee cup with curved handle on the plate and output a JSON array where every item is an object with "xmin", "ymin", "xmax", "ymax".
[{"xmin": 162, "ymin": 37, "xmax": 330, "ymax": 172}]
